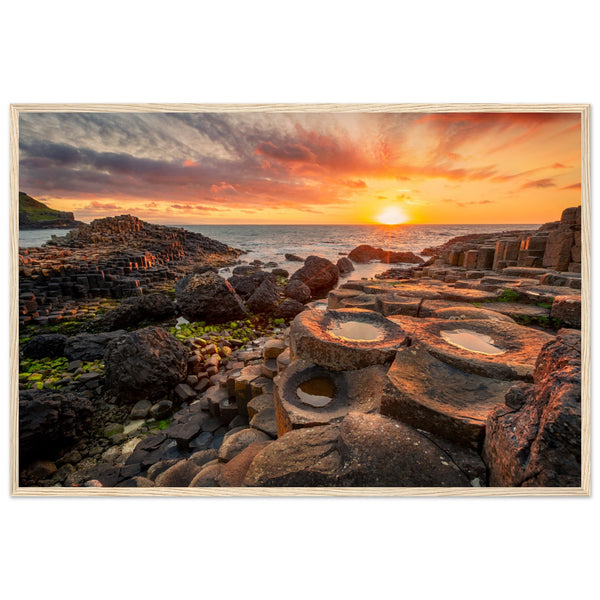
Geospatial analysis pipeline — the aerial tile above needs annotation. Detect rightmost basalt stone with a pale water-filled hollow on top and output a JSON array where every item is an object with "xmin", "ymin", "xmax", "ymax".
[{"xmin": 412, "ymin": 319, "xmax": 553, "ymax": 381}]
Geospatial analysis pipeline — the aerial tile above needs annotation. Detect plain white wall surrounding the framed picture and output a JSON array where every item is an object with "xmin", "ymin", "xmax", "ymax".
[{"xmin": 0, "ymin": 0, "xmax": 600, "ymax": 599}]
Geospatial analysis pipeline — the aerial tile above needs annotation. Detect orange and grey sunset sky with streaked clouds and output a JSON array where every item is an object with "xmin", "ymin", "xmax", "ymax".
[{"xmin": 19, "ymin": 112, "xmax": 581, "ymax": 225}]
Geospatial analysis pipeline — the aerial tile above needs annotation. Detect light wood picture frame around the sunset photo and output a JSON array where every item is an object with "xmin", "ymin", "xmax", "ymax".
[{"xmin": 9, "ymin": 103, "xmax": 591, "ymax": 497}]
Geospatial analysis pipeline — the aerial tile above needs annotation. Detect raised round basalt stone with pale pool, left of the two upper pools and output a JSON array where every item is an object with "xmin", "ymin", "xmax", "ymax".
[{"xmin": 290, "ymin": 308, "xmax": 406, "ymax": 371}]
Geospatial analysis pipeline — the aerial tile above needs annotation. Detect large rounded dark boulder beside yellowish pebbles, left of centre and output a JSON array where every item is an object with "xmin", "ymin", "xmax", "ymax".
[{"xmin": 104, "ymin": 327, "xmax": 188, "ymax": 402}]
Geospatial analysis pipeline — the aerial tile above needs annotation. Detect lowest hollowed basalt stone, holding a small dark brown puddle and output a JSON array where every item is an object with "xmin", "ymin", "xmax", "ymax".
[{"xmin": 274, "ymin": 360, "xmax": 387, "ymax": 436}]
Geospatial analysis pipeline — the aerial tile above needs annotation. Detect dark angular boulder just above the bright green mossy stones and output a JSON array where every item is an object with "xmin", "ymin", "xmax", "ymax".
[{"xmin": 176, "ymin": 272, "xmax": 247, "ymax": 323}]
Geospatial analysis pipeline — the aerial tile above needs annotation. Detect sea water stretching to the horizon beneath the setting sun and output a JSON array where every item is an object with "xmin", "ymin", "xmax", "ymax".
[{"xmin": 19, "ymin": 224, "xmax": 539, "ymax": 278}]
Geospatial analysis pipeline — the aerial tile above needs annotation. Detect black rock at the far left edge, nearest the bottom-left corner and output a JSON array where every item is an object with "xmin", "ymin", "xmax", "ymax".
[{"xmin": 19, "ymin": 390, "xmax": 93, "ymax": 464}]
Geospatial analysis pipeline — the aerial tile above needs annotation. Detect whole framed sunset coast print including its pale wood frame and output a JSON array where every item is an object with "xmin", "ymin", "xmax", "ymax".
[{"xmin": 10, "ymin": 104, "xmax": 590, "ymax": 496}]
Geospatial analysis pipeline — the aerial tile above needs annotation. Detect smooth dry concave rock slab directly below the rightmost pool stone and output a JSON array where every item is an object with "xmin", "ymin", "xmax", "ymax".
[{"xmin": 381, "ymin": 344, "xmax": 513, "ymax": 448}]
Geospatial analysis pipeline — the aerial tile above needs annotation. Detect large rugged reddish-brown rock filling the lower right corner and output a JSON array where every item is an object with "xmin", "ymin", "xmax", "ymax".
[{"xmin": 483, "ymin": 329, "xmax": 581, "ymax": 487}]
